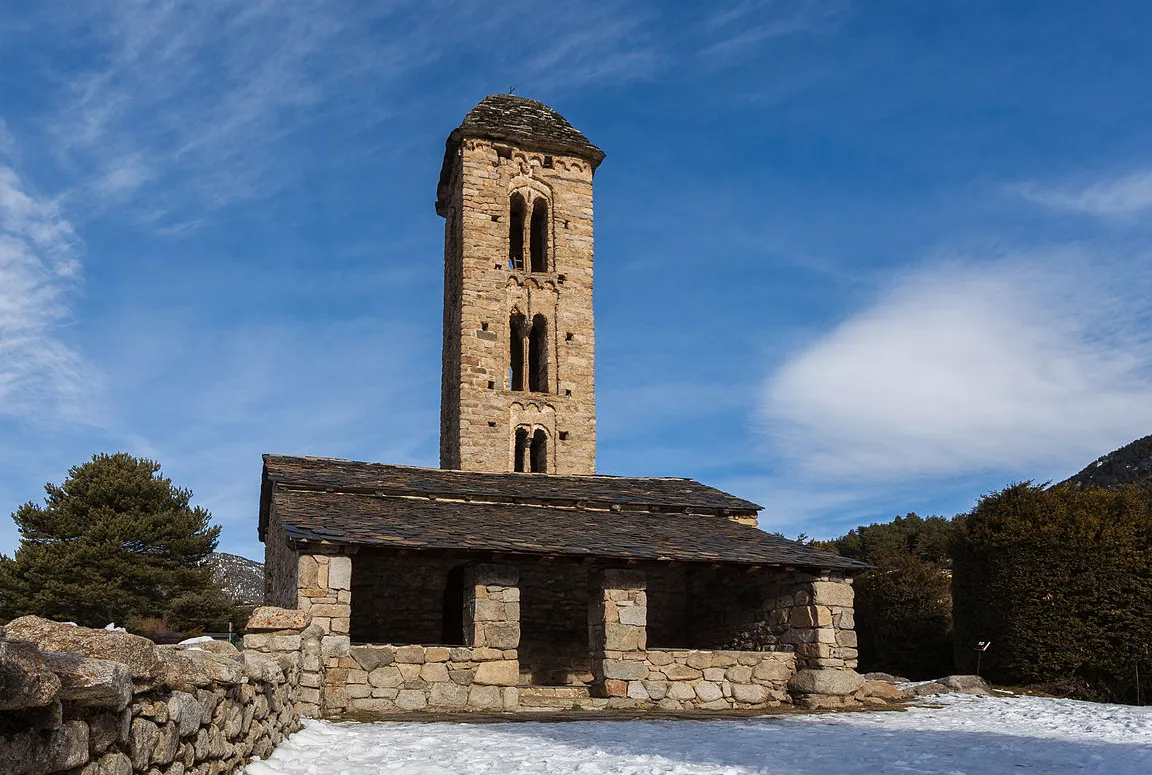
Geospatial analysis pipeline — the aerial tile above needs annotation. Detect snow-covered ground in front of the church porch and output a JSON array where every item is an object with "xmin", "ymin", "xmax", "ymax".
[{"xmin": 245, "ymin": 694, "xmax": 1152, "ymax": 775}]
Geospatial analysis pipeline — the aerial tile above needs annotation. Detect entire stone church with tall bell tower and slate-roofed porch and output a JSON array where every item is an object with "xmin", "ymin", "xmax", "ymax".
[{"xmin": 259, "ymin": 94, "xmax": 864, "ymax": 715}]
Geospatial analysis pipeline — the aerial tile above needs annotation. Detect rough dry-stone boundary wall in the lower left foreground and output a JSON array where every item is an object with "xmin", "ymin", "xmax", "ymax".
[{"xmin": 0, "ymin": 611, "xmax": 300, "ymax": 775}]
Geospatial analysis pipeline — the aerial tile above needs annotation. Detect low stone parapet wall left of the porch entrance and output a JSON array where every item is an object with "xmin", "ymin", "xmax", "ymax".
[{"xmin": 327, "ymin": 644, "xmax": 520, "ymax": 714}]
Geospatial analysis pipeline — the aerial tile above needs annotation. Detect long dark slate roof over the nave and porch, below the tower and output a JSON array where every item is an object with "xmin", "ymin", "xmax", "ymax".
[{"xmin": 260, "ymin": 455, "xmax": 866, "ymax": 570}]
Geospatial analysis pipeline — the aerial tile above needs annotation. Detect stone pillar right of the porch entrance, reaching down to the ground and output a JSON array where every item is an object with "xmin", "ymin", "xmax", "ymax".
[{"xmin": 588, "ymin": 568, "xmax": 647, "ymax": 697}]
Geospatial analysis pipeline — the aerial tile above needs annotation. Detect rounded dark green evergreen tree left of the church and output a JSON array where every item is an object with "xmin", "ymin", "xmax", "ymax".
[{"xmin": 0, "ymin": 453, "xmax": 230, "ymax": 630}]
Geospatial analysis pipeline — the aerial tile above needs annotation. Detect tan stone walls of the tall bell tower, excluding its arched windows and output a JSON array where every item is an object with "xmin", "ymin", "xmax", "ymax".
[{"xmin": 440, "ymin": 139, "xmax": 596, "ymax": 473}]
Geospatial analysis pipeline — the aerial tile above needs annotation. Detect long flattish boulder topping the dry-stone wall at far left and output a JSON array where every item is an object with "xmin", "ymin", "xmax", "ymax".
[{"xmin": 5, "ymin": 616, "xmax": 164, "ymax": 686}]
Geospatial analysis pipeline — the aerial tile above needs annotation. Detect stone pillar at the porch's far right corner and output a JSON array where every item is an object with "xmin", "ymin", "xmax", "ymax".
[{"xmin": 781, "ymin": 573, "xmax": 864, "ymax": 707}]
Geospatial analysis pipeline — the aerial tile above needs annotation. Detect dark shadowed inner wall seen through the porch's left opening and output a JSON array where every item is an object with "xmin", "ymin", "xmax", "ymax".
[{"xmin": 350, "ymin": 552, "xmax": 464, "ymax": 646}]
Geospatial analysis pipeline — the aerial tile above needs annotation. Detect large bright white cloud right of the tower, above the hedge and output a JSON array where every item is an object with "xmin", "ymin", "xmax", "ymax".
[{"xmin": 763, "ymin": 250, "xmax": 1152, "ymax": 480}]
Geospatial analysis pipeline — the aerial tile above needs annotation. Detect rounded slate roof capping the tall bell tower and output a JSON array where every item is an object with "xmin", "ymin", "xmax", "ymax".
[{"xmin": 437, "ymin": 94, "xmax": 604, "ymax": 213}]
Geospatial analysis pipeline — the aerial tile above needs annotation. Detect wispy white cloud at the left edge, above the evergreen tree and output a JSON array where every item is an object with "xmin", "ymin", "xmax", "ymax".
[{"xmin": 0, "ymin": 164, "xmax": 90, "ymax": 419}]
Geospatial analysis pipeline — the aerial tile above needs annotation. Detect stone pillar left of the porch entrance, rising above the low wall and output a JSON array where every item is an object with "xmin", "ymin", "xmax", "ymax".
[{"xmin": 464, "ymin": 563, "xmax": 520, "ymax": 659}]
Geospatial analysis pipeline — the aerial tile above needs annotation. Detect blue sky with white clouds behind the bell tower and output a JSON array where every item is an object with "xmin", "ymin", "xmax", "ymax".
[{"xmin": 0, "ymin": 0, "xmax": 1152, "ymax": 557}]
